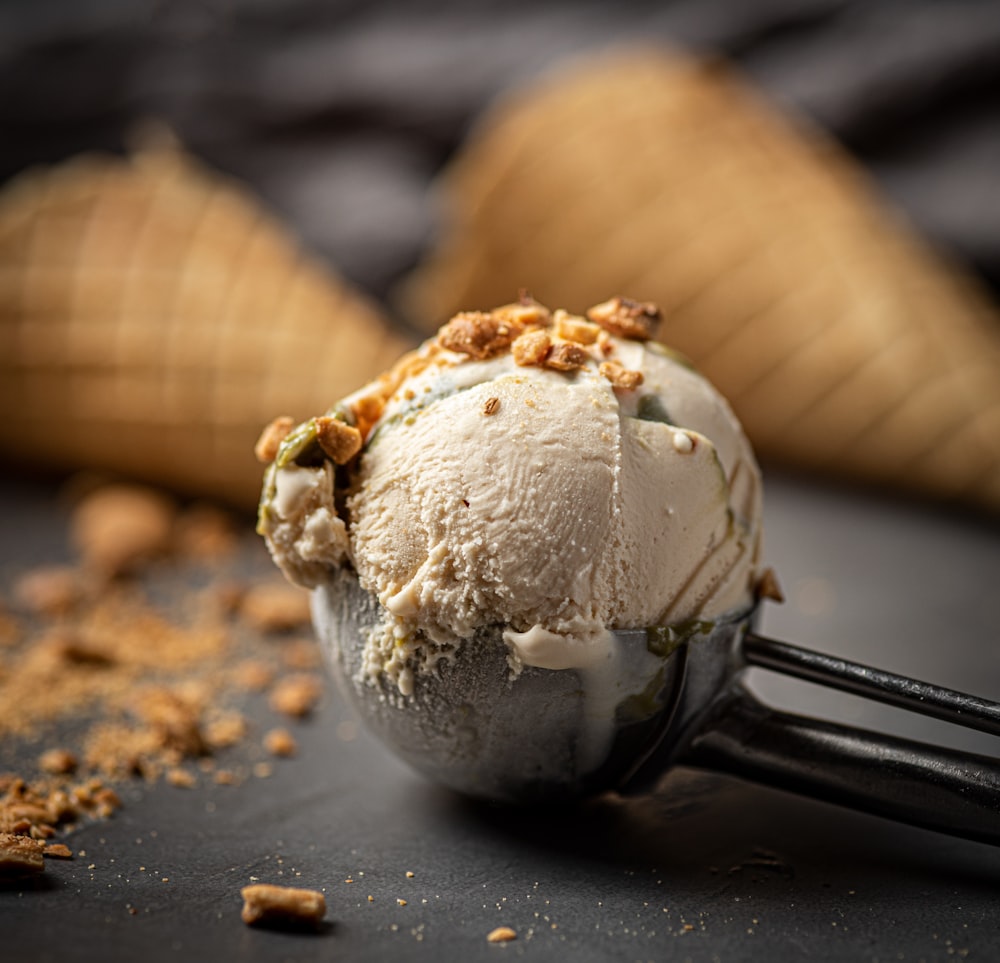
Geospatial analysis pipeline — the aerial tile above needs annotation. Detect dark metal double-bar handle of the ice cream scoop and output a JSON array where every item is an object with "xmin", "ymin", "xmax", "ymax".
[{"xmin": 623, "ymin": 633, "xmax": 1000, "ymax": 845}]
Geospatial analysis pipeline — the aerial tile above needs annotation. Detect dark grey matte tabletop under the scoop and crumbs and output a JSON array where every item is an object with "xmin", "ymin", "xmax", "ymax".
[{"xmin": 0, "ymin": 478, "xmax": 1000, "ymax": 963}]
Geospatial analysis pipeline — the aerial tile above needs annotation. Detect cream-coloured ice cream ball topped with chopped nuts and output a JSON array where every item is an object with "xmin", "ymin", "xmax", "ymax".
[{"xmin": 259, "ymin": 298, "xmax": 761, "ymax": 693}]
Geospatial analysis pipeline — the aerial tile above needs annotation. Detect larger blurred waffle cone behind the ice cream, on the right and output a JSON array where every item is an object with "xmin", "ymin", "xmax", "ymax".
[{"xmin": 403, "ymin": 51, "xmax": 1000, "ymax": 511}]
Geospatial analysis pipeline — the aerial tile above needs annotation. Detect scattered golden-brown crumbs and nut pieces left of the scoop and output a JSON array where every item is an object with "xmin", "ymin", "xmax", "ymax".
[{"xmin": 0, "ymin": 485, "xmax": 322, "ymax": 875}]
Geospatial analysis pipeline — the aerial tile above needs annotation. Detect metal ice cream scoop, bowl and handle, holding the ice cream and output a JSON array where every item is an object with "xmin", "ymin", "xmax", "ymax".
[{"xmin": 313, "ymin": 572, "xmax": 1000, "ymax": 844}]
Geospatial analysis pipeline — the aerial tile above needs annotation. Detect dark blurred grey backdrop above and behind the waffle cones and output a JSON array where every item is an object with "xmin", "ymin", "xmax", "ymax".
[{"xmin": 0, "ymin": 0, "xmax": 1000, "ymax": 308}]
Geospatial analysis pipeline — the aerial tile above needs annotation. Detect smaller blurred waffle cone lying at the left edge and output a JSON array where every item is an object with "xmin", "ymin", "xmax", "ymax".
[{"xmin": 0, "ymin": 149, "xmax": 407, "ymax": 506}]
